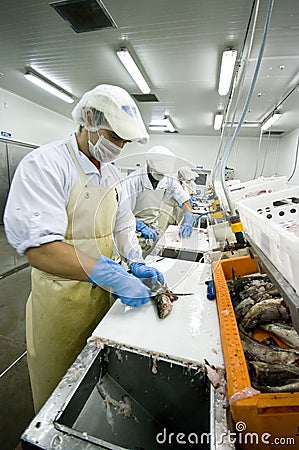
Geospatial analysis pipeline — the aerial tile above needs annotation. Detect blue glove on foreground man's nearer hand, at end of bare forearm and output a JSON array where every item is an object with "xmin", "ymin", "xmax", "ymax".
[{"xmin": 87, "ymin": 256, "xmax": 151, "ymax": 306}]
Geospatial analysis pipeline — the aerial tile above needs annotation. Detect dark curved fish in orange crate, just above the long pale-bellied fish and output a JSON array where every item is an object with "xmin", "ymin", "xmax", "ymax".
[{"xmin": 242, "ymin": 298, "xmax": 290, "ymax": 330}]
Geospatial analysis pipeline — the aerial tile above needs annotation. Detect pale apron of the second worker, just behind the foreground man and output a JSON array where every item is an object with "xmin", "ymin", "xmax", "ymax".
[{"xmin": 133, "ymin": 189, "xmax": 165, "ymax": 258}]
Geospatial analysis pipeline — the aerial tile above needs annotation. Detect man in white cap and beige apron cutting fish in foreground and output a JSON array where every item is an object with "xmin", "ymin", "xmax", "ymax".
[{"xmin": 4, "ymin": 84, "xmax": 164, "ymax": 412}]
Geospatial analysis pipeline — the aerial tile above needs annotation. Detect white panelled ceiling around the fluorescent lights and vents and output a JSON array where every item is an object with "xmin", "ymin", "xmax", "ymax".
[{"xmin": 0, "ymin": 0, "xmax": 299, "ymax": 136}]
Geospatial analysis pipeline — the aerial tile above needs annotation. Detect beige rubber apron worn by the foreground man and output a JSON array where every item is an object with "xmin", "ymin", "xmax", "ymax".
[{"xmin": 26, "ymin": 142, "xmax": 117, "ymax": 412}]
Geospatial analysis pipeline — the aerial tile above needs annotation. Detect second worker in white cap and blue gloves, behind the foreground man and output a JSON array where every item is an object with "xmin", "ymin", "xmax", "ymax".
[{"xmin": 124, "ymin": 145, "xmax": 194, "ymax": 256}]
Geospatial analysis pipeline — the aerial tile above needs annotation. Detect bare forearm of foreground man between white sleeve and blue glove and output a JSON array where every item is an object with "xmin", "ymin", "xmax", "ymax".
[{"xmin": 25, "ymin": 241, "xmax": 97, "ymax": 281}]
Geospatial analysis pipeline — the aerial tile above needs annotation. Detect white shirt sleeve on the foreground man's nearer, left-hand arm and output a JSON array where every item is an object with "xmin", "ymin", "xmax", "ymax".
[{"xmin": 4, "ymin": 147, "xmax": 68, "ymax": 255}]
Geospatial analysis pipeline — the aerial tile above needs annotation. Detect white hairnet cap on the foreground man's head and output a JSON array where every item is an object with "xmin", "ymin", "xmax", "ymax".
[{"xmin": 72, "ymin": 84, "xmax": 149, "ymax": 144}]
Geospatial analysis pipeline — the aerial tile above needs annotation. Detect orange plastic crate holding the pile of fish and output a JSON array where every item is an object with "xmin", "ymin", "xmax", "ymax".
[{"xmin": 213, "ymin": 256, "xmax": 299, "ymax": 450}]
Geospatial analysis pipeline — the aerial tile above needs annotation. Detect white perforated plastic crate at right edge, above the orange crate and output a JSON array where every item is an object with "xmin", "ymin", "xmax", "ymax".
[{"xmin": 237, "ymin": 186, "xmax": 299, "ymax": 294}]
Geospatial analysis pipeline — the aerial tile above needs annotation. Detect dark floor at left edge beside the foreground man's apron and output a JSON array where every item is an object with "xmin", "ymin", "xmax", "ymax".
[{"xmin": 0, "ymin": 225, "xmax": 34, "ymax": 450}]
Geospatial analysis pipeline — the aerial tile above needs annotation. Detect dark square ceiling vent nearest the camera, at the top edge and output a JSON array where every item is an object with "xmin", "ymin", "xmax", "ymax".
[{"xmin": 50, "ymin": 0, "xmax": 117, "ymax": 33}]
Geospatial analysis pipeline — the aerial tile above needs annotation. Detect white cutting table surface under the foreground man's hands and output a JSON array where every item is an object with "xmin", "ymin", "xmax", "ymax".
[{"xmin": 92, "ymin": 258, "xmax": 224, "ymax": 368}]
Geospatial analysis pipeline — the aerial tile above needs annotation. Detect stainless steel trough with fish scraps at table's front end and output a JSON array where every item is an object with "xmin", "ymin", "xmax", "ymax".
[{"xmin": 21, "ymin": 340, "xmax": 215, "ymax": 450}]
